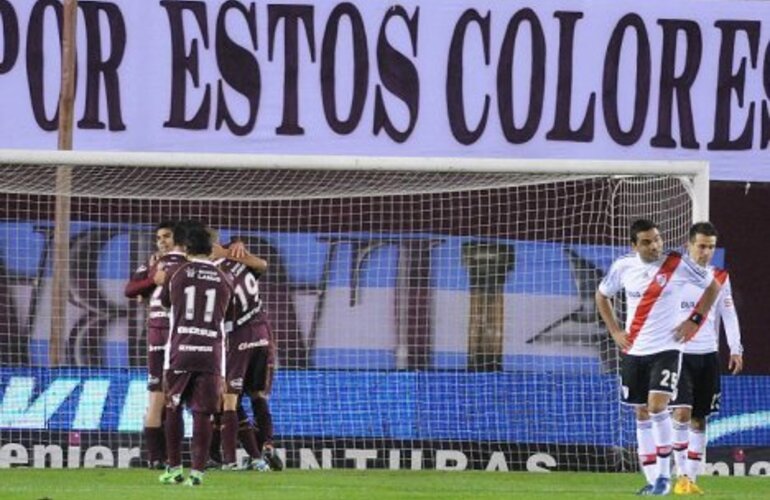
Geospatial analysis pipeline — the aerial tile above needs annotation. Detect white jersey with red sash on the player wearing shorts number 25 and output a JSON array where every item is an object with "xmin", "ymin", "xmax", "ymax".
[{"xmin": 599, "ymin": 252, "xmax": 714, "ymax": 356}]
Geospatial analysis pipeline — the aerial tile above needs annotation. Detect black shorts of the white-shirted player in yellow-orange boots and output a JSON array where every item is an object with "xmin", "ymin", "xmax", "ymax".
[{"xmin": 669, "ymin": 352, "xmax": 722, "ymax": 418}]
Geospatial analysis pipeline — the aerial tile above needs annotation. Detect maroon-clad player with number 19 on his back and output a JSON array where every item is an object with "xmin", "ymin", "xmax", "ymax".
[{"xmin": 214, "ymin": 236, "xmax": 283, "ymax": 472}]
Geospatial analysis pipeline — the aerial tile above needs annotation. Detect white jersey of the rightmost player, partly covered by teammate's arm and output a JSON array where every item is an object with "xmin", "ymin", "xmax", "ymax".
[{"xmin": 679, "ymin": 266, "xmax": 743, "ymax": 354}]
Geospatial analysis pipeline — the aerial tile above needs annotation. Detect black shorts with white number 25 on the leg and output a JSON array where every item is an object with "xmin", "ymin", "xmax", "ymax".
[{"xmin": 620, "ymin": 351, "xmax": 682, "ymax": 406}]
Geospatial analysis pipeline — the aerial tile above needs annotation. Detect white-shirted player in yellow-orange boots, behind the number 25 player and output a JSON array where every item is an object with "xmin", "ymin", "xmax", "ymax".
[{"xmin": 670, "ymin": 222, "xmax": 743, "ymax": 495}]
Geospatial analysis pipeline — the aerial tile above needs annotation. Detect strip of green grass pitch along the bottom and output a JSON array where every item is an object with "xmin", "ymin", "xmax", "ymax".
[{"xmin": 0, "ymin": 468, "xmax": 770, "ymax": 500}]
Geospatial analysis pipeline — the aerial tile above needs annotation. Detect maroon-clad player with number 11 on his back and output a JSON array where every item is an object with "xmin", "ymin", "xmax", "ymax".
[{"xmin": 159, "ymin": 221, "xmax": 233, "ymax": 486}]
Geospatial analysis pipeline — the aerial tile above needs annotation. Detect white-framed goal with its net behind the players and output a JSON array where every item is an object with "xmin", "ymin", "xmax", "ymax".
[{"xmin": 0, "ymin": 151, "xmax": 708, "ymax": 470}]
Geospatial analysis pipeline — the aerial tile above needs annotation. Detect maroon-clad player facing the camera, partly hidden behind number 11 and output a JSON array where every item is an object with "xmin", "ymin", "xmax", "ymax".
[{"xmin": 125, "ymin": 221, "xmax": 187, "ymax": 469}]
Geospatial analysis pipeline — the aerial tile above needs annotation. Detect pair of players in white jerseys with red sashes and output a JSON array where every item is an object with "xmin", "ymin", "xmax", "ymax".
[{"xmin": 596, "ymin": 219, "xmax": 743, "ymax": 495}]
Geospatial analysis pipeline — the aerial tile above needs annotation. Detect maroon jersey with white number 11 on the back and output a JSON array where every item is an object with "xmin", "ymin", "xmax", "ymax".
[{"xmin": 160, "ymin": 259, "xmax": 233, "ymax": 376}]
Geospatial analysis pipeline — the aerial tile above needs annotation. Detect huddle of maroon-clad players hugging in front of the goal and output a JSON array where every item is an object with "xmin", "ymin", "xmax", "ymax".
[{"xmin": 125, "ymin": 221, "xmax": 283, "ymax": 486}]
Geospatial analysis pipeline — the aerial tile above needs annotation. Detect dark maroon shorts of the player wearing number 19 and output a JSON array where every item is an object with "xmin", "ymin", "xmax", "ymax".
[{"xmin": 225, "ymin": 321, "xmax": 275, "ymax": 394}]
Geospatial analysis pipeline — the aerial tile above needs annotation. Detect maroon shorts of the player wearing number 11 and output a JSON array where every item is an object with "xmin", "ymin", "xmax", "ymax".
[{"xmin": 163, "ymin": 370, "xmax": 222, "ymax": 413}]
